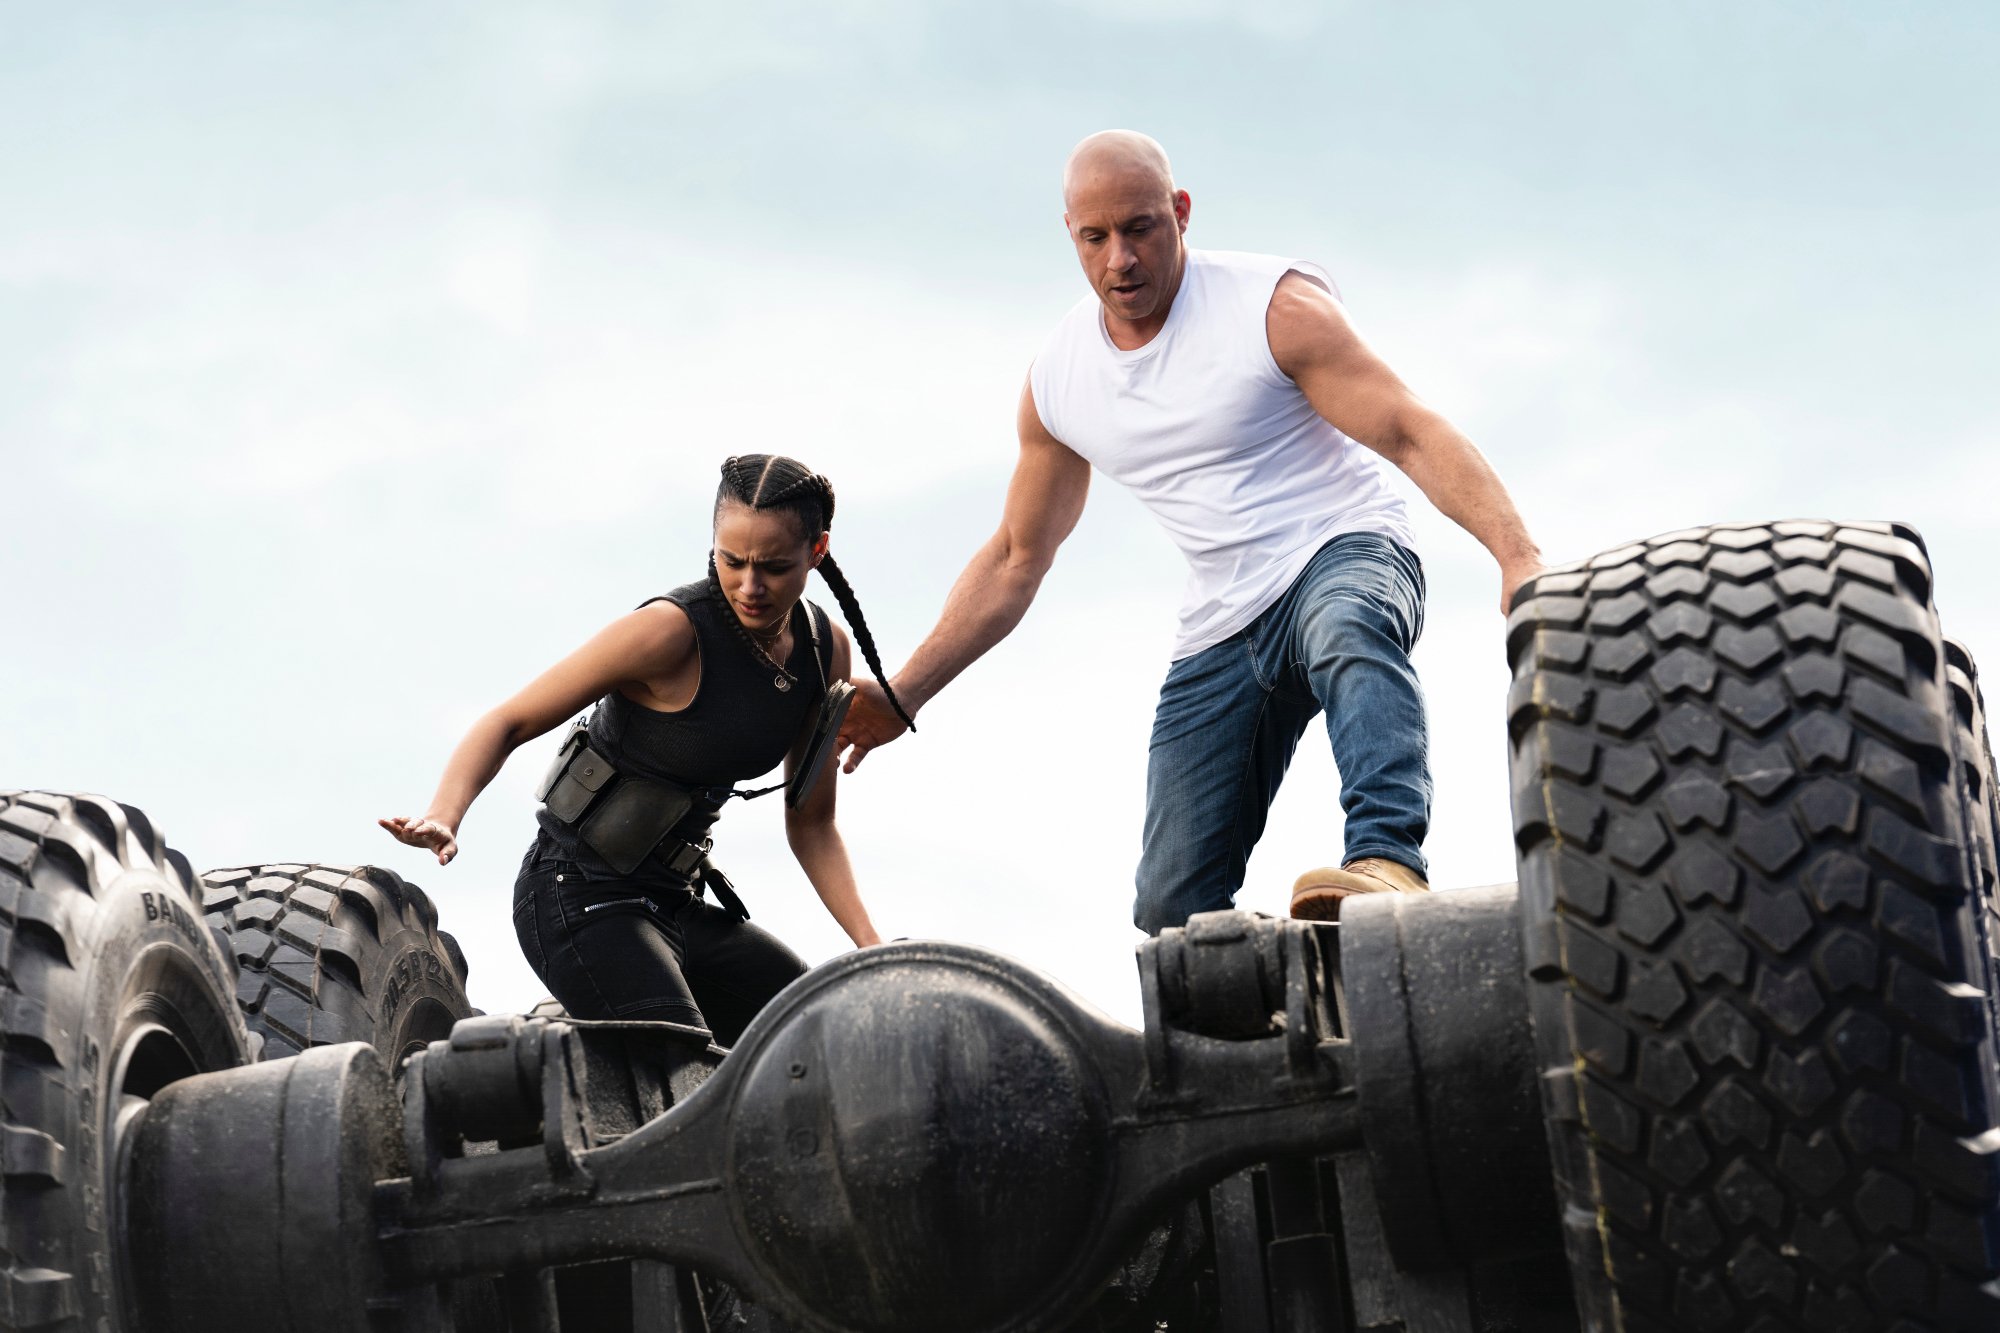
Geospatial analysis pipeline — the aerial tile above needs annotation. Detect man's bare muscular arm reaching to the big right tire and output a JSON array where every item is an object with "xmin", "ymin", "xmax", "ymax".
[{"xmin": 1266, "ymin": 272, "xmax": 1544, "ymax": 614}]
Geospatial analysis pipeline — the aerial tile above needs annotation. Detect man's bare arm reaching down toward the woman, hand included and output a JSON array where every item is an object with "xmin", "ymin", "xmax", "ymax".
[{"xmin": 840, "ymin": 374, "xmax": 1090, "ymax": 773}]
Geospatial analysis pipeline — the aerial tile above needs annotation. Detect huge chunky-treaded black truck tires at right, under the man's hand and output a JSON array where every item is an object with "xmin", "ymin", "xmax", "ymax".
[{"xmin": 1508, "ymin": 522, "xmax": 2000, "ymax": 1333}]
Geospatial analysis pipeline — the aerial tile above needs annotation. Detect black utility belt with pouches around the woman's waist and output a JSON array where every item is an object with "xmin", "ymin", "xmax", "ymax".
[{"xmin": 534, "ymin": 723, "xmax": 750, "ymax": 921}]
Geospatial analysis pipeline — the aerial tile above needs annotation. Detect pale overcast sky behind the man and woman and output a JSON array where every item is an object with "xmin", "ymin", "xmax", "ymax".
[{"xmin": 0, "ymin": 0, "xmax": 2000, "ymax": 1021}]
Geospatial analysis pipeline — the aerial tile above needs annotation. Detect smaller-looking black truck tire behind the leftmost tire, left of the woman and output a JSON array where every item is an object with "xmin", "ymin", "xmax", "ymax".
[{"xmin": 202, "ymin": 865, "xmax": 474, "ymax": 1071}]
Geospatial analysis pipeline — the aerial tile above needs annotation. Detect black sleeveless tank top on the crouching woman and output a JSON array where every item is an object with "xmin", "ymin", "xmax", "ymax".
[{"xmin": 536, "ymin": 578, "xmax": 834, "ymax": 875}]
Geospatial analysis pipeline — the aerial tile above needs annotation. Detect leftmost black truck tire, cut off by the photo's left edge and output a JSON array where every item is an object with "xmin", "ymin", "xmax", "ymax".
[{"xmin": 0, "ymin": 791, "xmax": 250, "ymax": 1333}]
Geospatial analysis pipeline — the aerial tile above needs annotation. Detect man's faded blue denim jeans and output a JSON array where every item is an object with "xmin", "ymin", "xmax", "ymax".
[{"xmin": 1132, "ymin": 532, "xmax": 1430, "ymax": 935}]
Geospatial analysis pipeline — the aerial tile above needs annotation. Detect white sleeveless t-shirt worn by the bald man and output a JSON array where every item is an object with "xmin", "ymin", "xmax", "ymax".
[{"xmin": 1028, "ymin": 250, "xmax": 1414, "ymax": 660}]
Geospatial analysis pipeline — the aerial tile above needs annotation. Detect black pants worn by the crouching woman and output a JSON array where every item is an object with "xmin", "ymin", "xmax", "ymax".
[{"xmin": 514, "ymin": 839, "xmax": 806, "ymax": 1047}]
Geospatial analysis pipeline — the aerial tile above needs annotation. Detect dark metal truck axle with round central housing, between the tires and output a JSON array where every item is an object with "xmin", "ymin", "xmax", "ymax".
[{"xmin": 118, "ymin": 885, "xmax": 1576, "ymax": 1333}]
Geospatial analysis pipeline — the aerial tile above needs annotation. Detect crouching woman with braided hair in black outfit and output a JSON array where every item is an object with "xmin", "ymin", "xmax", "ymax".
[{"xmin": 380, "ymin": 454, "xmax": 916, "ymax": 1045}]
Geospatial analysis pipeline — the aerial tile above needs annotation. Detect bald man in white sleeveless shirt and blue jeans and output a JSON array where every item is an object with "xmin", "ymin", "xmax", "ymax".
[{"xmin": 842, "ymin": 130, "xmax": 1542, "ymax": 933}]
